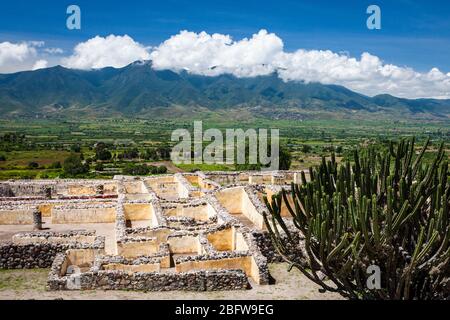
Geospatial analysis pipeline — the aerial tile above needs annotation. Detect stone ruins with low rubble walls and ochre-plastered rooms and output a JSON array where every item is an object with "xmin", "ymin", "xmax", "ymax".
[{"xmin": 0, "ymin": 171, "xmax": 306, "ymax": 291}]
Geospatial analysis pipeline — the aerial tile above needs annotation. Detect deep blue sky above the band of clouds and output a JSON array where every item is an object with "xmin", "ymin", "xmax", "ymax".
[{"xmin": 0, "ymin": 0, "xmax": 450, "ymax": 72}]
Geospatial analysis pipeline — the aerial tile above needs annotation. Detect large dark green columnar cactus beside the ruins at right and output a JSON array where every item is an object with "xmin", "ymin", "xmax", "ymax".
[{"xmin": 264, "ymin": 139, "xmax": 450, "ymax": 299}]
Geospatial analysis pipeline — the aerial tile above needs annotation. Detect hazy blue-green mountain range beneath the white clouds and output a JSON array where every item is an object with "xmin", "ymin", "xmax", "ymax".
[{"xmin": 0, "ymin": 61, "xmax": 450, "ymax": 120}]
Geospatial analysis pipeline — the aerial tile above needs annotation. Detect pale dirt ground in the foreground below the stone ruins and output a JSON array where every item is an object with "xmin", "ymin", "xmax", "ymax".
[{"xmin": 0, "ymin": 263, "xmax": 342, "ymax": 300}]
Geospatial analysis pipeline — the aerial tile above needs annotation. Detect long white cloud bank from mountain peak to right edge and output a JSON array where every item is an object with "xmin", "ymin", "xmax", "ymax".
[{"xmin": 151, "ymin": 30, "xmax": 450, "ymax": 98}]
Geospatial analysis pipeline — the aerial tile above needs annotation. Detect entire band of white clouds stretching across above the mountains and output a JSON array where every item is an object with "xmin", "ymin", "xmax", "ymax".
[{"xmin": 0, "ymin": 30, "xmax": 450, "ymax": 98}]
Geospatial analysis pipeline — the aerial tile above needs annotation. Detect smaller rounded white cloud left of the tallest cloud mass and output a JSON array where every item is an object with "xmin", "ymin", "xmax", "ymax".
[{"xmin": 62, "ymin": 35, "xmax": 150, "ymax": 69}]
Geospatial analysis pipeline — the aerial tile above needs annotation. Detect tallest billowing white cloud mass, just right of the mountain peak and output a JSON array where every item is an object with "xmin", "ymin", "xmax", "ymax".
[{"xmin": 151, "ymin": 30, "xmax": 283, "ymax": 77}]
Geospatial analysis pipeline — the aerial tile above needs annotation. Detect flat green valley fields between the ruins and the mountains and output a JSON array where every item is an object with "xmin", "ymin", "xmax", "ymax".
[{"xmin": 0, "ymin": 116, "xmax": 450, "ymax": 180}]
